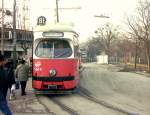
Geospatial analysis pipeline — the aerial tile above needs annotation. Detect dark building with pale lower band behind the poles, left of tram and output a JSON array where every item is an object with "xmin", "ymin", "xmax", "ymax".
[{"xmin": 0, "ymin": 28, "xmax": 33, "ymax": 58}]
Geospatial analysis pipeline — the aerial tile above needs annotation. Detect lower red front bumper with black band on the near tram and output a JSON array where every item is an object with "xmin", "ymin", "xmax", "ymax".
[{"xmin": 32, "ymin": 76, "xmax": 76, "ymax": 90}]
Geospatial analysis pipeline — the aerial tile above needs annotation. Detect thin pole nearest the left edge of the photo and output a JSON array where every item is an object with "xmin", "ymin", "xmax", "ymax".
[{"xmin": 1, "ymin": 0, "xmax": 4, "ymax": 55}]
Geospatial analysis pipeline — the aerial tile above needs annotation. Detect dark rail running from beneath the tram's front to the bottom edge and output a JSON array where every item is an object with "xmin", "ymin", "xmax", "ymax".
[{"xmin": 51, "ymin": 98, "xmax": 79, "ymax": 115}]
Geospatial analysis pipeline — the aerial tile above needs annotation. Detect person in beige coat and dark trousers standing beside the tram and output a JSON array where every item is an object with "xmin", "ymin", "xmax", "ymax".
[{"xmin": 15, "ymin": 59, "xmax": 30, "ymax": 96}]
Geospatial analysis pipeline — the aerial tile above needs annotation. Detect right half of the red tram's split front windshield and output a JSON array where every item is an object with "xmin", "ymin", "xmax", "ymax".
[{"xmin": 54, "ymin": 40, "xmax": 72, "ymax": 58}]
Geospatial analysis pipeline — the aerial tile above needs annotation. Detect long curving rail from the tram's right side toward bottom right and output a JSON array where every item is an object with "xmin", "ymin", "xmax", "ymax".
[{"xmin": 78, "ymin": 86, "xmax": 139, "ymax": 115}]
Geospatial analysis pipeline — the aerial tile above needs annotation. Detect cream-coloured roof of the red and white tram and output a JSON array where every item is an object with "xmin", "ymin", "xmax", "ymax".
[{"xmin": 34, "ymin": 23, "xmax": 78, "ymax": 36}]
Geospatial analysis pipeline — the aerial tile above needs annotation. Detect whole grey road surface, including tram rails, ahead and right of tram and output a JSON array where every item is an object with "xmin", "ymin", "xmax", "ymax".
[{"xmin": 38, "ymin": 63, "xmax": 150, "ymax": 115}]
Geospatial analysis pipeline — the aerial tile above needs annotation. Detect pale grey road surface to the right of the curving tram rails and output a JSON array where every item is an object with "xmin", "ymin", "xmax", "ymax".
[{"xmin": 80, "ymin": 64, "xmax": 150, "ymax": 115}]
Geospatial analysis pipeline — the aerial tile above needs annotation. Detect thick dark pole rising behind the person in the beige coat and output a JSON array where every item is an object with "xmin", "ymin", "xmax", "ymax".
[{"xmin": 13, "ymin": 0, "xmax": 17, "ymax": 68}]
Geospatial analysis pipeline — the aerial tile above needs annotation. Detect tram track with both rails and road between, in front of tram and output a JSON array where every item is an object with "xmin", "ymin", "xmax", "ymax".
[{"xmin": 37, "ymin": 87, "xmax": 139, "ymax": 115}]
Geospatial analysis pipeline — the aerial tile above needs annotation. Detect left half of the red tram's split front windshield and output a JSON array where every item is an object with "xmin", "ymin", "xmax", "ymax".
[{"xmin": 35, "ymin": 40, "xmax": 53, "ymax": 58}]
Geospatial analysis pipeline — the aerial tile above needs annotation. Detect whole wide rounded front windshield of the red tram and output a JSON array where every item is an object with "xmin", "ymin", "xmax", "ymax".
[{"xmin": 35, "ymin": 39, "xmax": 72, "ymax": 58}]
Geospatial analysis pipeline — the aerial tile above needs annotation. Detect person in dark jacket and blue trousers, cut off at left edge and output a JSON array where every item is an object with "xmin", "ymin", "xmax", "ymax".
[{"xmin": 0, "ymin": 55, "xmax": 12, "ymax": 115}]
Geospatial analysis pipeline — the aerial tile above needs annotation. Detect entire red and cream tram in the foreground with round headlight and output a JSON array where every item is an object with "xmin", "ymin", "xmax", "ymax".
[{"xmin": 32, "ymin": 25, "xmax": 80, "ymax": 93}]
